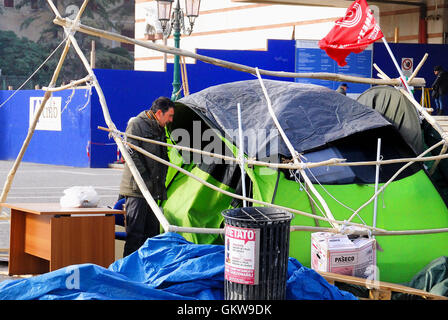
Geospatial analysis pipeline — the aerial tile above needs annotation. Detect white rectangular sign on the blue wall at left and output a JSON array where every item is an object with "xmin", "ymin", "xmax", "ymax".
[{"xmin": 29, "ymin": 97, "xmax": 62, "ymax": 131}]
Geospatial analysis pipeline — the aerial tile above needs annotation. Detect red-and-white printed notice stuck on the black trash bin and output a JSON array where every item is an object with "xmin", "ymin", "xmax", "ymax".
[{"xmin": 224, "ymin": 225, "xmax": 260, "ymax": 285}]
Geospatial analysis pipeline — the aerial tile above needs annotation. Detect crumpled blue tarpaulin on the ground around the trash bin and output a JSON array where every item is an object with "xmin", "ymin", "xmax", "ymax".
[{"xmin": 0, "ymin": 233, "xmax": 356, "ymax": 300}]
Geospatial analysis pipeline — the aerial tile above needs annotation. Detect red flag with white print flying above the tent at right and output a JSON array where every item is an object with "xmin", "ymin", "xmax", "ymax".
[{"xmin": 319, "ymin": 0, "xmax": 384, "ymax": 67}]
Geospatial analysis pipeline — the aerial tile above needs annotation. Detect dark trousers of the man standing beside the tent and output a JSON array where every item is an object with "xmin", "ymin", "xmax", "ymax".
[{"xmin": 123, "ymin": 197, "xmax": 160, "ymax": 257}]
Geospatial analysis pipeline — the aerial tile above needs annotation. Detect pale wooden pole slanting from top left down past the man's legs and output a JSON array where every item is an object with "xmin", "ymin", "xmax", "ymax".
[{"xmin": 47, "ymin": 0, "xmax": 169, "ymax": 231}]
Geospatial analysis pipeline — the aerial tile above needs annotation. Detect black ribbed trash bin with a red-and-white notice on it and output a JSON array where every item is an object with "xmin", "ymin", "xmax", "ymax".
[{"xmin": 222, "ymin": 207, "xmax": 293, "ymax": 300}]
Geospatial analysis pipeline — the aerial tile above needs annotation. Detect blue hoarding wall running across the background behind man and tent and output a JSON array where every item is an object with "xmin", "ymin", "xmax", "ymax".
[{"xmin": 6, "ymin": 40, "xmax": 448, "ymax": 167}]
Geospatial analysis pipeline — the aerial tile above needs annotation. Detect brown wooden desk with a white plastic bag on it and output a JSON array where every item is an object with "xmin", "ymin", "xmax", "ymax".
[{"xmin": 0, "ymin": 203, "xmax": 125, "ymax": 275}]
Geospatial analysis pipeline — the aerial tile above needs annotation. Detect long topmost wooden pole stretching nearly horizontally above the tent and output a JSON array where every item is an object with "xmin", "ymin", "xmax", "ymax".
[{"xmin": 53, "ymin": 17, "xmax": 426, "ymax": 87}]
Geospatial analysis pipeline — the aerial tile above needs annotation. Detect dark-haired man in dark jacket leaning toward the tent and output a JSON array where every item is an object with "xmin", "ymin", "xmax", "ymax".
[{"xmin": 120, "ymin": 97, "xmax": 174, "ymax": 257}]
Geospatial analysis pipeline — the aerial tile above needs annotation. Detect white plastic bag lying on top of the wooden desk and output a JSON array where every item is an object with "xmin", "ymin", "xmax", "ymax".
[{"xmin": 59, "ymin": 186, "xmax": 100, "ymax": 208}]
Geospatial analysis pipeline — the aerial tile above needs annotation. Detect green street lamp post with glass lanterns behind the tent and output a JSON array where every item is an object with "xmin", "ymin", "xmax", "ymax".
[{"xmin": 157, "ymin": 0, "xmax": 201, "ymax": 101}]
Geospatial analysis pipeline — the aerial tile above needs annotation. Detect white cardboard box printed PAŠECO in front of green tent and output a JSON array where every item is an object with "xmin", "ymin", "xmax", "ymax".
[{"xmin": 311, "ymin": 232, "xmax": 376, "ymax": 278}]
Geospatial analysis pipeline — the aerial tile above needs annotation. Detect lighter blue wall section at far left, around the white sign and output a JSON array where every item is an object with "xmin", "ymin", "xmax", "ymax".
[{"xmin": 0, "ymin": 89, "xmax": 90, "ymax": 167}]
